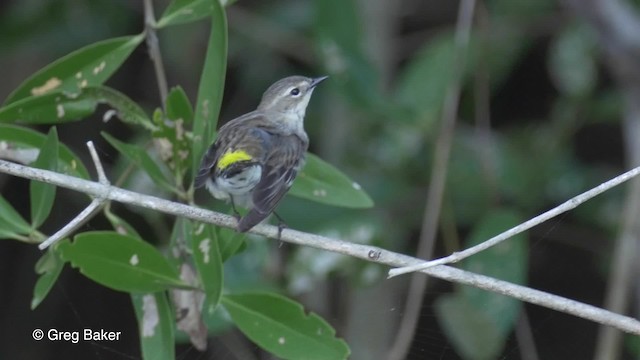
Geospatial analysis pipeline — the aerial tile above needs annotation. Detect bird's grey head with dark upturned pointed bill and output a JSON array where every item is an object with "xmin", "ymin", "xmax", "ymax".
[{"xmin": 258, "ymin": 76, "xmax": 327, "ymax": 121}]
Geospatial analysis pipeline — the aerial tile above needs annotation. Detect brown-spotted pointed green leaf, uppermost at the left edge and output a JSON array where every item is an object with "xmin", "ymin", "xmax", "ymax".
[{"xmin": 5, "ymin": 34, "xmax": 144, "ymax": 105}]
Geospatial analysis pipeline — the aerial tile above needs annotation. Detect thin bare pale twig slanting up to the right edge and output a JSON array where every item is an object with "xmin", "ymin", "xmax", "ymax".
[{"xmin": 389, "ymin": 167, "xmax": 640, "ymax": 278}]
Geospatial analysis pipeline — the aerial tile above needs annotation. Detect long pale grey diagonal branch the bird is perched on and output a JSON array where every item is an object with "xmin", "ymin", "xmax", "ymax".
[{"xmin": 0, "ymin": 160, "xmax": 640, "ymax": 335}]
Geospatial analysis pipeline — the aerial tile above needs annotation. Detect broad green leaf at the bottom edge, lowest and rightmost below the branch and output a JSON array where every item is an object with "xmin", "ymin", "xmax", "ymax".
[{"xmin": 222, "ymin": 293, "xmax": 350, "ymax": 360}]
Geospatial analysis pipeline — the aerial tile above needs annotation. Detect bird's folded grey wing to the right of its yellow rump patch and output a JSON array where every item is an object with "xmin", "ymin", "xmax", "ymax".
[{"xmin": 238, "ymin": 135, "xmax": 307, "ymax": 232}]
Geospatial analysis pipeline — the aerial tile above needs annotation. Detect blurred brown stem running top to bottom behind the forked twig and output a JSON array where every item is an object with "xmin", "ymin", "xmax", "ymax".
[{"xmin": 389, "ymin": 0, "xmax": 475, "ymax": 360}]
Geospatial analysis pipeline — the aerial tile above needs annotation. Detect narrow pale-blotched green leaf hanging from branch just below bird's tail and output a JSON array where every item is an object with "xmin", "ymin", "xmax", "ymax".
[{"xmin": 191, "ymin": 223, "xmax": 224, "ymax": 317}]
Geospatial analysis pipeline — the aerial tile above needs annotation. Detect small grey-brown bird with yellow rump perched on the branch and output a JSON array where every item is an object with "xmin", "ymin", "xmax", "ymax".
[{"xmin": 195, "ymin": 76, "xmax": 327, "ymax": 232}]
